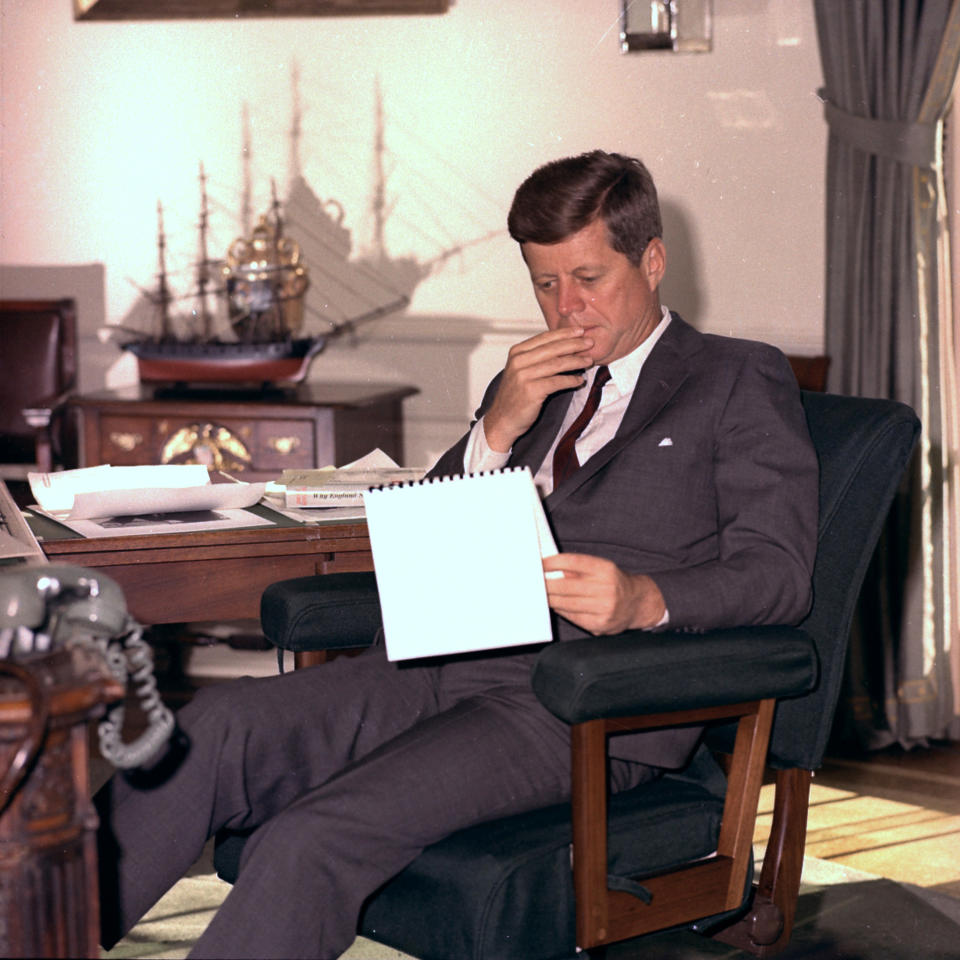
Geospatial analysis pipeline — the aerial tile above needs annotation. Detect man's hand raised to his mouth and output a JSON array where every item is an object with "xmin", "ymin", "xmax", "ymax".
[{"xmin": 483, "ymin": 327, "xmax": 593, "ymax": 453}]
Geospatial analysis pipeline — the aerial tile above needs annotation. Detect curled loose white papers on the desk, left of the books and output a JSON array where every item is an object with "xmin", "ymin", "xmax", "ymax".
[{"xmin": 28, "ymin": 464, "xmax": 265, "ymax": 520}]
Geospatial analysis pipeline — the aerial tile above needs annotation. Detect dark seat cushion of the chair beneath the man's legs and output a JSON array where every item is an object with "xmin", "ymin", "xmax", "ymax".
[{"xmin": 214, "ymin": 774, "xmax": 723, "ymax": 960}]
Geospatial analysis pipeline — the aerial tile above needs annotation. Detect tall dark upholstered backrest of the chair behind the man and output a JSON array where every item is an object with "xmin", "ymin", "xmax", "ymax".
[{"xmin": 770, "ymin": 392, "xmax": 920, "ymax": 770}]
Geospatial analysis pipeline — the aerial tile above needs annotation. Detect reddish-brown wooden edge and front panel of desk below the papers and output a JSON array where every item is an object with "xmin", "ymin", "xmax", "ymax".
[{"xmin": 30, "ymin": 507, "xmax": 373, "ymax": 625}]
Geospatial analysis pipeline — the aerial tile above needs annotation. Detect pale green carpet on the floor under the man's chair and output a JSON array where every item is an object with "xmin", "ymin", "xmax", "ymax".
[{"xmin": 102, "ymin": 851, "xmax": 960, "ymax": 960}]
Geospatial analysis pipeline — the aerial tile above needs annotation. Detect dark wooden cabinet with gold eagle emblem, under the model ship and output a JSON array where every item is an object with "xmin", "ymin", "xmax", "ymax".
[{"xmin": 72, "ymin": 383, "xmax": 417, "ymax": 480}]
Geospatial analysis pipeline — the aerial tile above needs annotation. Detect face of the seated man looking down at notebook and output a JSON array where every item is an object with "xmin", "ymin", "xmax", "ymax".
[{"xmin": 522, "ymin": 219, "xmax": 666, "ymax": 365}]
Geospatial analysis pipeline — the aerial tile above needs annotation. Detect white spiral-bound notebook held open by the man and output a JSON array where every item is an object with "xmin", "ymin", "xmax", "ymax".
[{"xmin": 363, "ymin": 467, "xmax": 557, "ymax": 660}]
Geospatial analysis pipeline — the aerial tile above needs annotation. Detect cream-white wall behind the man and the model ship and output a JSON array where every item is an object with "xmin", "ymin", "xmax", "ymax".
[{"xmin": 0, "ymin": 0, "xmax": 826, "ymax": 462}]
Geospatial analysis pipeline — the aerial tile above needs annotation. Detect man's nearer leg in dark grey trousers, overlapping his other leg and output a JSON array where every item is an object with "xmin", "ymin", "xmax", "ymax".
[{"xmin": 191, "ymin": 696, "xmax": 569, "ymax": 960}]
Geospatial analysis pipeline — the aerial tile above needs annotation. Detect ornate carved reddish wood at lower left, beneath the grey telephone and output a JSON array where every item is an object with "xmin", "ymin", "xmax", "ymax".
[{"xmin": 0, "ymin": 651, "xmax": 124, "ymax": 957}]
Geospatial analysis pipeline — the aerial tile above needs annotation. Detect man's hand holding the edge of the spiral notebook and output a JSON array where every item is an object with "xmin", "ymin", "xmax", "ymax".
[{"xmin": 543, "ymin": 553, "xmax": 667, "ymax": 634}]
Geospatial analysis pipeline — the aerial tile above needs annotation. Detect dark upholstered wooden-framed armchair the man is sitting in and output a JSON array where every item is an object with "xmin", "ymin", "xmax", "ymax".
[{"xmin": 215, "ymin": 393, "xmax": 919, "ymax": 960}]
